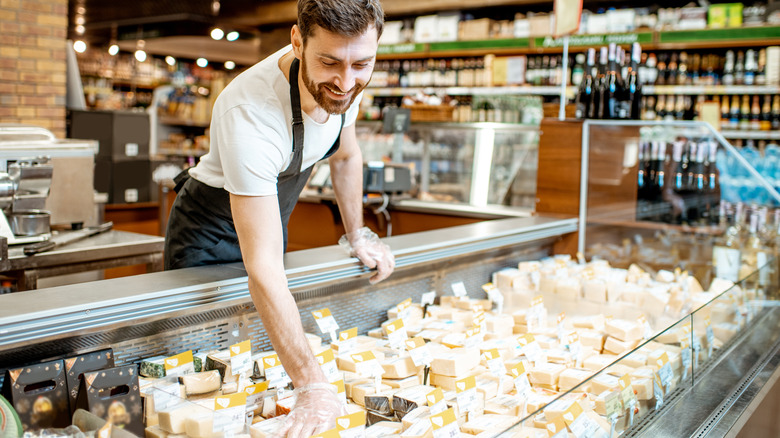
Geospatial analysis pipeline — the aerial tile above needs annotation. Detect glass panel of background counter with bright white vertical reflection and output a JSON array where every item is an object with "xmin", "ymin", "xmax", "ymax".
[{"xmin": 357, "ymin": 121, "xmax": 539, "ymax": 210}]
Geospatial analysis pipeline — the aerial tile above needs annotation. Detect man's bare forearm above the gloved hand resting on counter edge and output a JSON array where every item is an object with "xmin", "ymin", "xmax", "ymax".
[{"xmin": 330, "ymin": 155, "xmax": 363, "ymax": 233}]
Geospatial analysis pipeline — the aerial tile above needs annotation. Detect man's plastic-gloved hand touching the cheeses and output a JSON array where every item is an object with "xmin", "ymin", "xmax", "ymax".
[{"xmin": 274, "ymin": 383, "xmax": 347, "ymax": 438}]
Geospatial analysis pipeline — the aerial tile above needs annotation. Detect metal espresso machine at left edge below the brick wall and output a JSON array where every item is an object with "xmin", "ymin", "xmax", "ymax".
[{"xmin": 0, "ymin": 123, "xmax": 98, "ymax": 245}]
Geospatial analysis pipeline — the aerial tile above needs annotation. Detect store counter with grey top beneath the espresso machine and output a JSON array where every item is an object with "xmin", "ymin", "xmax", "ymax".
[{"xmin": 0, "ymin": 230, "xmax": 165, "ymax": 291}]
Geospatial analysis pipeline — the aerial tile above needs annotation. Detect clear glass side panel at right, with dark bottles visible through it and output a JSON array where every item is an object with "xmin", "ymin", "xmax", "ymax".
[{"xmin": 580, "ymin": 121, "xmax": 780, "ymax": 288}]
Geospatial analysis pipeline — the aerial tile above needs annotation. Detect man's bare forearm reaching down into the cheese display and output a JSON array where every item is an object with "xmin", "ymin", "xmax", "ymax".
[{"xmin": 249, "ymin": 278, "xmax": 327, "ymax": 387}]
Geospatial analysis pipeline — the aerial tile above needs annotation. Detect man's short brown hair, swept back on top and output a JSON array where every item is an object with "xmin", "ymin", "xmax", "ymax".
[{"xmin": 298, "ymin": 0, "xmax": 385, "ymax": 42}]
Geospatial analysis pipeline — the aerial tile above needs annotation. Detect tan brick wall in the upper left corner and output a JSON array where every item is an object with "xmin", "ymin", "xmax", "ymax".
[{"xmin": 0, "ymin": 0, "xmax": 68, "ymax": 137}]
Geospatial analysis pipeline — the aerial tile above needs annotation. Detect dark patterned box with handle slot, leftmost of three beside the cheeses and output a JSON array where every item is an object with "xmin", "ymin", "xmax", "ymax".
[{"xmin": 3, "ymin": 360, "xmax": 71, "ymax": 431}]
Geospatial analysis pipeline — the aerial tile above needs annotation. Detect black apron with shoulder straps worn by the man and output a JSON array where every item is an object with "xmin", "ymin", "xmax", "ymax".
[{"xmin": 164, "ymin": 58, "xmax": 344, "ymax": 270}]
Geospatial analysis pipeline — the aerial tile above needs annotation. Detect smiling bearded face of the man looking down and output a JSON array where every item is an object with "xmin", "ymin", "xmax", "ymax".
[{"xmin": 301, "ymin": 26, "xmax": 378, "ymax": 114}]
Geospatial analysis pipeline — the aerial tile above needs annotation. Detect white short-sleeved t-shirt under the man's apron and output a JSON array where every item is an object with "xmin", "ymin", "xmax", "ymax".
[{"xmin": 190, "ymin": 45, "xmax": 363, "ymax": 196}]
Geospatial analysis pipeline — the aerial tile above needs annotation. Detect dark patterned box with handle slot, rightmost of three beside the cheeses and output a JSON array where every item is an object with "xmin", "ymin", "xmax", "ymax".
[{"xmin": 76, "ymin": 365, "xmax": 144, "ymax": 436}]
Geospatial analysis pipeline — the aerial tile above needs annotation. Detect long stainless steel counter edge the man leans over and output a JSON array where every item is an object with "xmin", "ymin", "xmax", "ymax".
[{"xmin": 0, "ymin": 216, "xmax": 577, "ymax": 350}]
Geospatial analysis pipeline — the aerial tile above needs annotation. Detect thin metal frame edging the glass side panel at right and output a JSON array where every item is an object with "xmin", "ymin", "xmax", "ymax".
[{"xmin": 577, "ymin": 120, "xmax": 780, "ymax": 254}]
